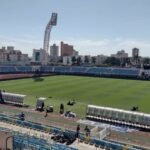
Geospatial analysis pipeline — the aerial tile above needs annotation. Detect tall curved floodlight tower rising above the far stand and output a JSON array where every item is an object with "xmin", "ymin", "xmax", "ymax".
[{"xmin": 43, "ymin": 13, "xmax": 57, "ymax": 65}]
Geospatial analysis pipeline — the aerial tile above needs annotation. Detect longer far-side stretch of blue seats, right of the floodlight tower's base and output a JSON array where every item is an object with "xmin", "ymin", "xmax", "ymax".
[{"xmin": 41, "ymin": 66, "xmax": 140, "ymax": 77}]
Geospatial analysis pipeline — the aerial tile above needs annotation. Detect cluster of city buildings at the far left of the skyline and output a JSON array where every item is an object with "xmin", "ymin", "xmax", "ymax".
[{"xmin": 0, "ymin": 46, "xmax": 30, "ymax": 65}]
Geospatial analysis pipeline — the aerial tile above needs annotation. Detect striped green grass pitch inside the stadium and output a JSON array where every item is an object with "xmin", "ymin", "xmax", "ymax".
[{"xmin": 0, "ymin": 76, "xmax": 150, "ymax": 117}]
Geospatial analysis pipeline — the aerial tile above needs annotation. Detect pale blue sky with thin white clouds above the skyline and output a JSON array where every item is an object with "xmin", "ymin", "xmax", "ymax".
[{"xmin": 0, "ymin": 0, "xmax": 150, "ymax": 56}]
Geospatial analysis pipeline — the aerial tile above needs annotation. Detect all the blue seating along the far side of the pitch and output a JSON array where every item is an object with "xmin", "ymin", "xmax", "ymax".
[{"xmin": 0, "ymin": 66, "xmax": 140, "ymax": 77}]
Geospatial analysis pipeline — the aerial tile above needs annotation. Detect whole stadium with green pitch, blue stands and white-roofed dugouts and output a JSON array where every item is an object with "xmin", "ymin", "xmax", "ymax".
[{"xmin": 0, "ymin": 66, "xmax": 150, "ymax": 150}]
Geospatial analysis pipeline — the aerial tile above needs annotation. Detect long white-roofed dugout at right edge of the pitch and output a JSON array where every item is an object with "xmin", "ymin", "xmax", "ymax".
[{"xmin": 87, "ymin": 105, "xmax": 150, "ymax": 128}]
